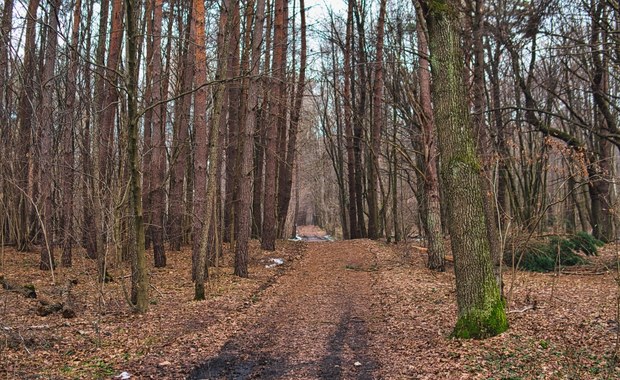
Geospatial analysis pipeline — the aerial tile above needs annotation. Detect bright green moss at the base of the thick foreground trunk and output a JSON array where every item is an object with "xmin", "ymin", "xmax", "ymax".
[{"xmin": 452, "ymin": 300, "xmax": 508, "ymax": 339}]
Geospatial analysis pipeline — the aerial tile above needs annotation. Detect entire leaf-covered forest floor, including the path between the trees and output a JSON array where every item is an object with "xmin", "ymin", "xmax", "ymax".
[{"xmin": 0, "ymin": 228, "xmax": 620, "ymax": 379}]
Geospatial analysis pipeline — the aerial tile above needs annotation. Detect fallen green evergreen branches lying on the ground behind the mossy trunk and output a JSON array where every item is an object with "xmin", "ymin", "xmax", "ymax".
[{"xmin": 505, "ymin": 232, "xmax": 604, "ymax": 272}]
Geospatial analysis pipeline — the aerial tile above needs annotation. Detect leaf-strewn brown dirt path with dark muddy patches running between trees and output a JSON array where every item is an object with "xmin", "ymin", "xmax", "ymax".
[{"xmin": 189, "ymin": 241, "xmax": 380, "ymax": 379}]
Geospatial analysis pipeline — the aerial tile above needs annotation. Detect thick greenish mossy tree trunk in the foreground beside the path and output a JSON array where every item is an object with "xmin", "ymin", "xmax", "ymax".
[{"xmin": 423, "ymin": 0, "xmax": 508, "ymax": 339}]
